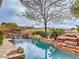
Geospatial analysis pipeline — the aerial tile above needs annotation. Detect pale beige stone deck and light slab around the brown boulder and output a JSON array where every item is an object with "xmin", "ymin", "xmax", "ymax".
[{"xmin": 0, "ymin": 38, "xmax": 24, "ymax": 59}]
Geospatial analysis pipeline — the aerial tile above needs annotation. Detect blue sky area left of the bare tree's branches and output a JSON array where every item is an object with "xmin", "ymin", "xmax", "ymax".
[{"xmin": 0, "ymin": 0, "xmax": 31, "ymax": 25}]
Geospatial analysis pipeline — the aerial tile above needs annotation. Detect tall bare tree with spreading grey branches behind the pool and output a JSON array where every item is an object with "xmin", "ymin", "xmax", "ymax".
[{"xmin": 20, "ymin": 0, "xmax": 72, "ymax": 33}]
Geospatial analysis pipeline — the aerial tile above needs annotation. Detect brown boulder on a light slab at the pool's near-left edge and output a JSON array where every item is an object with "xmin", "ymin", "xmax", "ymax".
[{"xmin": 7, "ymin": 47, "xmax": 24, "ymax": 59}]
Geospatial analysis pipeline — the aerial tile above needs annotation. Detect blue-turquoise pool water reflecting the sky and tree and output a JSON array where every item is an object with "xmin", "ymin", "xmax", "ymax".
[{"xmin": 13, "ymin": 39, "xmax": 79, "ymax": 59}]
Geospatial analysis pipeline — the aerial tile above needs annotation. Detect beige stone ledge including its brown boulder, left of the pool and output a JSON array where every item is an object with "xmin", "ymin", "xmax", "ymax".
[{"xmin": 0, "ymin": 38, "xmax": 24, "ymax": 59}]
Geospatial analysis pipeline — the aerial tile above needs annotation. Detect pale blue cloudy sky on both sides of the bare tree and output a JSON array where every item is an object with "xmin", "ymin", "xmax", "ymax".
[{"xmin": 0, "ymin": 0, "xmax": 79, "ymax": 28}]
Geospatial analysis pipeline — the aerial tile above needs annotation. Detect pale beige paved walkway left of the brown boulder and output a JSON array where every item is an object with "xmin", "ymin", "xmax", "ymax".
[{"xmin": 0, "ymin": 39, "xmax": 17, "ymax": 59}]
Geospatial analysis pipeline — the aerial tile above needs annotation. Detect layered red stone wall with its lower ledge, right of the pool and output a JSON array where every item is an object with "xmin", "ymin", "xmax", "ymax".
[{"xmin": 56, "ymin": 34, "xmax": 79, "ymax": 55}]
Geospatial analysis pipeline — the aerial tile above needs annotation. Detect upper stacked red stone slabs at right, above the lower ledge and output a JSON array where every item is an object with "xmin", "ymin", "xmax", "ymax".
[{"xmin": 56, "ymin": 34, "xmax": 79, "ymax": 46}]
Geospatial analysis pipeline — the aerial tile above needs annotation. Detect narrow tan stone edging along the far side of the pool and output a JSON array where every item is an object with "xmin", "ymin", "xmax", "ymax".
[{"xmin": 29, "ymin": 35, "xmax": 79, "ymax": 55}]
